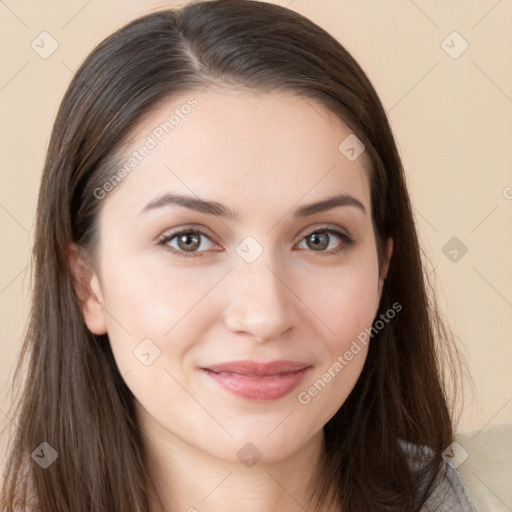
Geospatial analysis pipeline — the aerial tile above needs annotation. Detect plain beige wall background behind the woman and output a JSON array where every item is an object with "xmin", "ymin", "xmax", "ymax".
[{"xmin": 0, "ymin": 0, "xmax": 512, "ymax": 446}]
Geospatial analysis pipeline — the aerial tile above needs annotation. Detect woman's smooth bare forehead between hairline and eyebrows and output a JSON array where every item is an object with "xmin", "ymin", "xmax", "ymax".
[{"xmin": 103, "ymin": 85, "xmax": 370, "ymax": 218}]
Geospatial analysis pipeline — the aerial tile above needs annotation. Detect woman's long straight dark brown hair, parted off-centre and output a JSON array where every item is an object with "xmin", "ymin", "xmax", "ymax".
[{"xmin": 0, "ymin": 0, "xmax": 466, "ymax": 512}]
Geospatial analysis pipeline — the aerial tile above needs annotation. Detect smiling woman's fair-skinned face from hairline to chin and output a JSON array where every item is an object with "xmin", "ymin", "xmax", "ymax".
[{"xmin": 78, "ymin": 87, "xmax": 391, "ymax": 468}]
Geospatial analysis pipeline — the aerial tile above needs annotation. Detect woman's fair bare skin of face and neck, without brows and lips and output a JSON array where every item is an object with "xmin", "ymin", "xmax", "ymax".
[{"xmin": 72, "ymin": 86, "xmax": 392, "ymax": 512}]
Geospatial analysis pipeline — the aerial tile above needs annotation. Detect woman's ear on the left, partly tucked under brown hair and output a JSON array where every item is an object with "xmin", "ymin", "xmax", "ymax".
[{"xmin": 68, "ymin": 244, "xmax": 107, "ymax": 335}]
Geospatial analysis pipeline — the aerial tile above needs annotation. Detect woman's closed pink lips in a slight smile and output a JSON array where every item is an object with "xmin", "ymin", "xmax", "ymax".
[{"xmin": 202, "ymin": 361, "xmax": 311, "ymax": 401}]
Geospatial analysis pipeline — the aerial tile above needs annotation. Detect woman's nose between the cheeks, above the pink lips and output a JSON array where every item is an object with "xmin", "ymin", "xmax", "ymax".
[{"xmin": 224, "ymin": 255, "xmax": 300, "ymax": 342}]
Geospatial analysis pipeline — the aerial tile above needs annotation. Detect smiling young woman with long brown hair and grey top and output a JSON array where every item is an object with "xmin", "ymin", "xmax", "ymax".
[{"xmin": 1, "ymin": 0, "xmax": 474, "ymax": 512}]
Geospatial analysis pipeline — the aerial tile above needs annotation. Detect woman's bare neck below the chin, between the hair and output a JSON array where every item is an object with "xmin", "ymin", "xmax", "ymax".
[{"xmin": 140, "ymin": 416, "xmax": 334, "ymax": 512}]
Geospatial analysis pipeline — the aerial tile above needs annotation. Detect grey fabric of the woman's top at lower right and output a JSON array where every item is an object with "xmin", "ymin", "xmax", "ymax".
[{"xmin": 400, "ymin": 441, "xmax": 476, "ymax": 512}]
